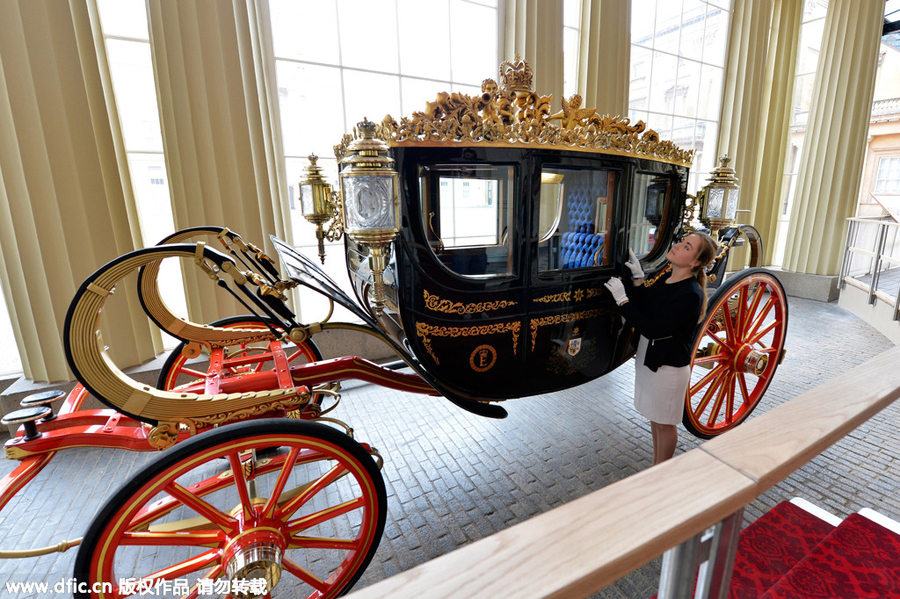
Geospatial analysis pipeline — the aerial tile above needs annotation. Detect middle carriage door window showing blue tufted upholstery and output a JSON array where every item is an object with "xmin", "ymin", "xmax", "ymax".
[{"xmin": 538, "ymin": 168, "xmax": 616, "ymax": 271}]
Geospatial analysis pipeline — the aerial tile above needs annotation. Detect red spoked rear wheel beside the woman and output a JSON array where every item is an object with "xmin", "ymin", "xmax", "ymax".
[{"xmin": 683, "ymin": 268, "xmax": 788, "ymax": 439}]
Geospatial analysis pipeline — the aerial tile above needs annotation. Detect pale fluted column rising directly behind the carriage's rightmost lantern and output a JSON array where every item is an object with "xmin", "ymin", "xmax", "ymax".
[{"xmin": 716, "ymin": 0, "xmax": 772, "ymax": 251}]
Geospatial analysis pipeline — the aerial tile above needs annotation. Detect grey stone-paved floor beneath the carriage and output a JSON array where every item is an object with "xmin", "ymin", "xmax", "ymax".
[{"xmin": 0, "ymin": 298, "xmax": 900, "ymax": 599}]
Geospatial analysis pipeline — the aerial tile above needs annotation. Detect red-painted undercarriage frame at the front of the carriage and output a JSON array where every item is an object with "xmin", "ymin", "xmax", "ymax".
[{"xmin": 0, "ymin": 341, "xmax": 438, "ymax": 509}]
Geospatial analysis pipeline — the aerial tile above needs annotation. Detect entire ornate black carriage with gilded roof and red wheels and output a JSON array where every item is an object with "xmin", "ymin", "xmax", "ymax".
[{"xmin": 0, "ymin": 60, "xmax": 787, "ymax": 597}]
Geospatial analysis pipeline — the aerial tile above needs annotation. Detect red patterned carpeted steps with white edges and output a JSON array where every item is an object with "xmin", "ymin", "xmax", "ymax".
[{"xmin": 696, "ymin": 499, "xmax": 900, "ymax": 599}]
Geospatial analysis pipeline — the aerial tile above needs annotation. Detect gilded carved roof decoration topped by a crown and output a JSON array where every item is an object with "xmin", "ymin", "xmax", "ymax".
[{"xmin": 334, "ymin": 56, "xmax": 694, "ymax": 166}]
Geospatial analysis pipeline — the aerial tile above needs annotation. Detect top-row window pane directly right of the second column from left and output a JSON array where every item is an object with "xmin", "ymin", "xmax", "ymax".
[{"xmin": 270, "ymin": 0, "xmax": 340, "ymax": 65}]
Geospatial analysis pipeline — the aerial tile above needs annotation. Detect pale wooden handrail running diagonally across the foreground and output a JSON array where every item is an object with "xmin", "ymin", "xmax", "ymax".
[{"xmin": 348, "ymin": 346, "xmax": 900, "ymax": 599}]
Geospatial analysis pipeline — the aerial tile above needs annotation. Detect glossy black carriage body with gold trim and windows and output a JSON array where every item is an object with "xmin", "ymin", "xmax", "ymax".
[{"xmin": 347, "ymin": 144, "xmax": 688, "ymax": 400}]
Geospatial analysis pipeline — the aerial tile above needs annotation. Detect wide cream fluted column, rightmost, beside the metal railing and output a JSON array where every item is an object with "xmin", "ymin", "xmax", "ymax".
[{"xmin": 784, "ymin": 0, "xmax": 884, "ymax": 275}]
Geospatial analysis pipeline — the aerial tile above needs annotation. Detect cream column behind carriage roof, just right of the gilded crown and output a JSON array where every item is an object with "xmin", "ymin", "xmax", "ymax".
[{"xmin": 578, "ymin": 0, "xmax": 631, "ymax": 117}]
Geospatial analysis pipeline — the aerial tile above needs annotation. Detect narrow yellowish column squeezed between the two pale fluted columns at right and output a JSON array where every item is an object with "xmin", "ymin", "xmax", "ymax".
[{"xmin": 749, "ymin": 0, "xmax": 803, "ymax": 255}]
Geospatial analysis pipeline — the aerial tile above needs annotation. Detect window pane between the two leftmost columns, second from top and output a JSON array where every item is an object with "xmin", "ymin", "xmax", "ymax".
[{"xmin": 106, "ymin": 39, "xmax": 162, "ymax": 152}]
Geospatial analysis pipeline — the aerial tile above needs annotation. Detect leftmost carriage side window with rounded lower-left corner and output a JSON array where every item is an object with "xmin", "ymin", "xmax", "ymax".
[{"xmin": 419, "ymin": 165, "xmax": 513, "ymax": 276}]
